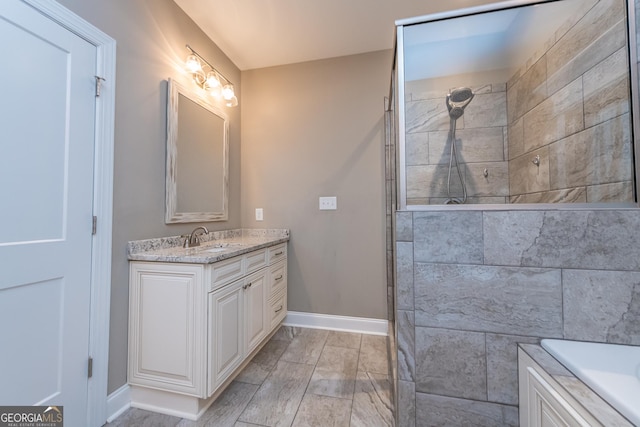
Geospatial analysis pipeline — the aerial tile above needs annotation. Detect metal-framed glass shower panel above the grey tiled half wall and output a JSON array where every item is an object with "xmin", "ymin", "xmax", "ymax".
[{"xmin": 397, "ymin": 0, "xmax": 638, "ymax": 209}]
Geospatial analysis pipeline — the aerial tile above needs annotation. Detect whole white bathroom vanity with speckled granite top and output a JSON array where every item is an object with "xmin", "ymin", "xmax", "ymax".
[{"xmin": 128, "ymin": 230, "xmax": 289, "ymax": 419}]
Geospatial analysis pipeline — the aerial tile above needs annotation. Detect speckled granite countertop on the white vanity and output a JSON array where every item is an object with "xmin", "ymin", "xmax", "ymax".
[{"xmin": 127, "ymin": 229, "xmax": 289, "ymax": 264}]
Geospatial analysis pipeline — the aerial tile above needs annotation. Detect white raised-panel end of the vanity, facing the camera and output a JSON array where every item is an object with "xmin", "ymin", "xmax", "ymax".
[{"xmin": 129, "ymin": 262, "xmax": 206, "ymax": 397}]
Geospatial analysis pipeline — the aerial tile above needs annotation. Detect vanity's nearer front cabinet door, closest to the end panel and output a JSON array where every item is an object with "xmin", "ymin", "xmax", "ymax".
[{"xmin": 207, "ymin": 280, "xmax": 245, "ymax": 396}]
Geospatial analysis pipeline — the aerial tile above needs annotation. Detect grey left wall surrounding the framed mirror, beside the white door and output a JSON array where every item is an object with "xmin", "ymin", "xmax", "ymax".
[{"xmin": 53, "ymin": 0, "xmax": 241, "ymax": 393}]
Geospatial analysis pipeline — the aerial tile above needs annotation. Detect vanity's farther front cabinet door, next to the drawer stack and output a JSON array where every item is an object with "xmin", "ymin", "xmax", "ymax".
[{"xmin": 243, "ymin": 269, "xmax": 267, "ymax": 355}]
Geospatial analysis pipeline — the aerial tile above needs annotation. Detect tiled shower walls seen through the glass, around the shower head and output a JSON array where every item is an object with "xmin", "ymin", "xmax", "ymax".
[{"xmin": 405, "ymin": 0, "xmax": 634, "ymax": 205}]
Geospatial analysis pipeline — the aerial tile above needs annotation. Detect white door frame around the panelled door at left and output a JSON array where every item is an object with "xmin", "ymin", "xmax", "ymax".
[{"xmin": 22, "ymin": 0, "xmax": 116, "ymax": 427}]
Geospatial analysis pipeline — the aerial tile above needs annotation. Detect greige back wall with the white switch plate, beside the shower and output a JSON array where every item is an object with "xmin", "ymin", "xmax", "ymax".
[{"xmin": 242, "ymin": 51, "xmax": 392, "ymax": 319}]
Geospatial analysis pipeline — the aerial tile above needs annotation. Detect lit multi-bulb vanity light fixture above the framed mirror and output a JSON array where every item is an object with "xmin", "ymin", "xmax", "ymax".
[{"xmin": 185, "ymin": 45, "xmax": 238, "ymax": 107}]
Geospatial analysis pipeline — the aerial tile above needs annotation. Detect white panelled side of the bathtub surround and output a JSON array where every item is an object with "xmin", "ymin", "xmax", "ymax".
[{"xmin": 518, "ymin": 349, "xmax": 602, "ymax": 427}]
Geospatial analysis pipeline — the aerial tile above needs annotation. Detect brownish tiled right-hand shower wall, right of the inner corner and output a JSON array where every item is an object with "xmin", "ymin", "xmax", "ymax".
[{"xmin": 507, "ymin": 0, "xmax": 633, "ymax": 203}]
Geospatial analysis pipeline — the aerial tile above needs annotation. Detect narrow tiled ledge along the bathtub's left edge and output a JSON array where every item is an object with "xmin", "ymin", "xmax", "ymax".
[{"xmin": 519, "ymin": 343, "xmax": 633, "ymax": 427}]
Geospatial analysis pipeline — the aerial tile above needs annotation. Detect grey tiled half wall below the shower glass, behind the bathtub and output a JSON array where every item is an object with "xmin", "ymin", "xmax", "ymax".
[{"xmin": 396, "ymin": 210, "xmax": 640, "ymax": 426}]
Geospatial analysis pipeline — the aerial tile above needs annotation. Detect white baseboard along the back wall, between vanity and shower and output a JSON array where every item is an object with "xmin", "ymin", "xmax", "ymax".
[{"xmin": 282, "ymin": 311, "xmax": 389, "ymax": 336}]
